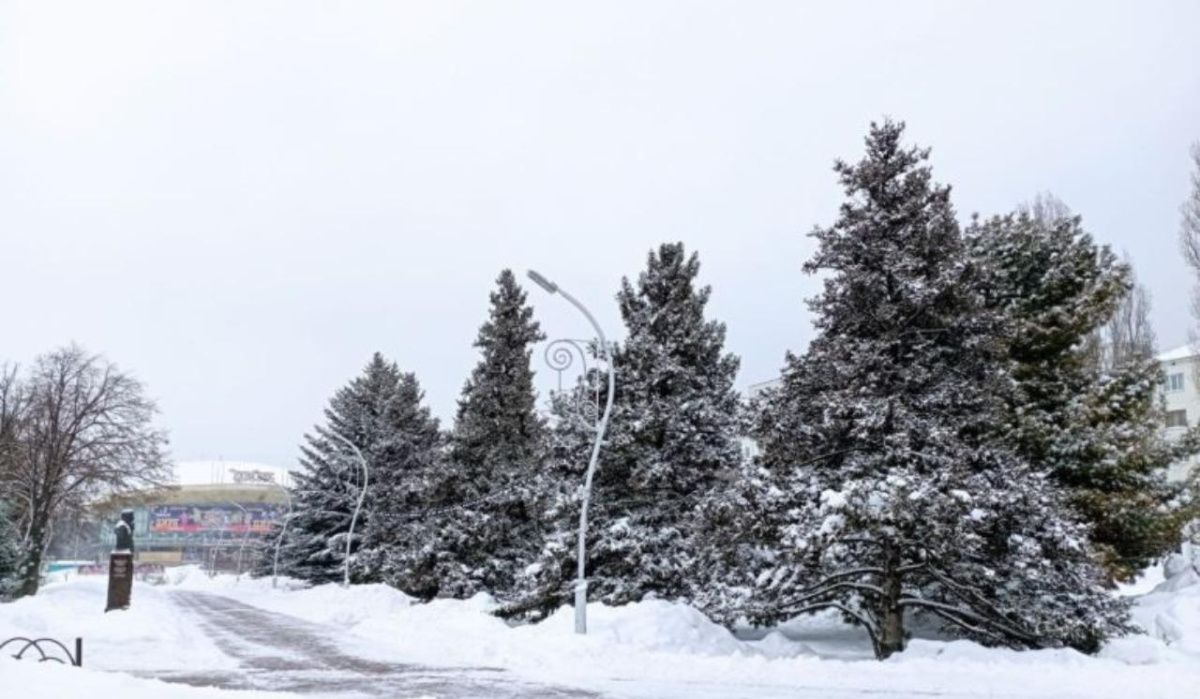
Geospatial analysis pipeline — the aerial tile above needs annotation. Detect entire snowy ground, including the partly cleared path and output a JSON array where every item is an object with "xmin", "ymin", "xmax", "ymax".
[{"xmin": 0, "ymin": 566, "xmax": 1200, "ymax": 699}]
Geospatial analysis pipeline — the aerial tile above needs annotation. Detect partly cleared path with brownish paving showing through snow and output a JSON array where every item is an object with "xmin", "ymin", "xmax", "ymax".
[{"xmin": 142, "ymin": 591, "xmax": 596, "ymax": 699}]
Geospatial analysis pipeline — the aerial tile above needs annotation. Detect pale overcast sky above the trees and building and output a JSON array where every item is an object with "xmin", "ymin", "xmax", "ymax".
[{"xmin": 0, "ymin": 0, "xmax": 1200, "ymax": 465}]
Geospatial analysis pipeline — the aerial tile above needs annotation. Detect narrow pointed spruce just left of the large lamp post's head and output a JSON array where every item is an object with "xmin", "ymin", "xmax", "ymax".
[{"xmin": 430, "ymin": 269, "xmax": 545, "ymax": 597}]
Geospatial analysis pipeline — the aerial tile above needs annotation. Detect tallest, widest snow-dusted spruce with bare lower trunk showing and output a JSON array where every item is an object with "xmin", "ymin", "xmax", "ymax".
[{"xmin": 748, "ymin": 121, "xmax": 1127, "ymax": 658}]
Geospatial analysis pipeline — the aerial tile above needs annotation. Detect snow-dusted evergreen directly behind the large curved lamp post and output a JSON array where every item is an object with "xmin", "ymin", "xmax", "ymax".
[{"xmin": 513, "ymin": 243, "xmax": 742, "ymax": 607}]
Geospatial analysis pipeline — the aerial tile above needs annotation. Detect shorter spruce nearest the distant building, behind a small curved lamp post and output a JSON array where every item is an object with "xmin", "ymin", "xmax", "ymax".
[{"xmin": 267, "ymin": 353, "xmax": 427, "ymax": 583}]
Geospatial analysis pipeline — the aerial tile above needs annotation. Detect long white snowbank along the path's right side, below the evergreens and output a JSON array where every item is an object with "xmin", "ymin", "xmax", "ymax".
[{"xmin": 171, "ymin": 566, "xmax": 1200, "ymax": 698}]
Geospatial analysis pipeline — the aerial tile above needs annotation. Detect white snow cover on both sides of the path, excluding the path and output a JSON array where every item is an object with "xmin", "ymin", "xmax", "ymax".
[{"xmin": 0, "ymin": 561, "xmax": 1200, "ymax": 699}]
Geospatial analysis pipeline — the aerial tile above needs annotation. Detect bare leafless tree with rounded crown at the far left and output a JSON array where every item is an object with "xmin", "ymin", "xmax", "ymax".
[{"xmin": 2, "ymin": 346, "xmax": 169, "ymax": 596}]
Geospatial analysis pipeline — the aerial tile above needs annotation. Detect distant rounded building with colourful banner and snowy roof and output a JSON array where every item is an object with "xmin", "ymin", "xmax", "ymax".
[{"xmin": 100, "ymin": 461, "xmax": 290, "ymax": 570}]
